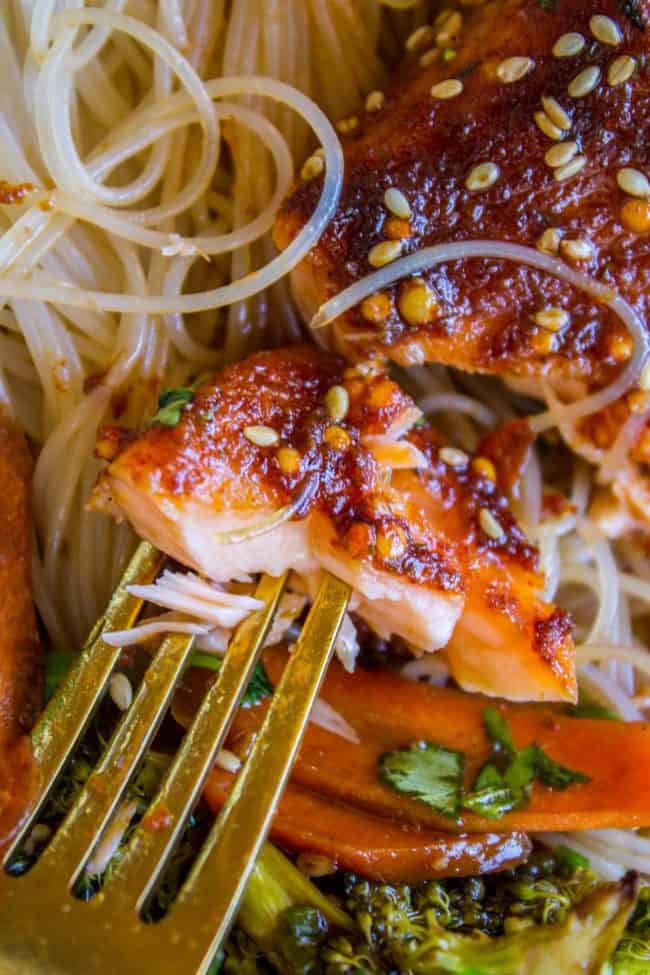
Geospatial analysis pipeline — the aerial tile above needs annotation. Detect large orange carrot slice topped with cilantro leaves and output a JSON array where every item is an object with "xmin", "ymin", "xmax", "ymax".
[{"xmin": 256, "ymin": 649, "xmax": 650, "ymax": 832}]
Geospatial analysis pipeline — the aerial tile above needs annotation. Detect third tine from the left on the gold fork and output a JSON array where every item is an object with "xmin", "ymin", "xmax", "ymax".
[{"xmin": 112, "ymin": 573, "xmax": 288, "ymax": 910}]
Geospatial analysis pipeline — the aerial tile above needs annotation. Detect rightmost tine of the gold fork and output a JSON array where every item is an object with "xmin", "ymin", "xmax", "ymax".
[{"xmin": 166, "ymin": 575, "xmax": 350, "ymax": 973}]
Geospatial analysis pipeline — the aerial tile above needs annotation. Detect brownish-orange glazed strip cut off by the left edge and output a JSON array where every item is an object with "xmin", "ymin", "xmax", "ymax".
[{"xmin": 0, "ymin": 417, "xmax": 43, "ymax": 845}]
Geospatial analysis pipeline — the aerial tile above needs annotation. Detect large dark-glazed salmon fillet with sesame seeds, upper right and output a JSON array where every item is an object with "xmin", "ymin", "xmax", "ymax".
[{"xmin": 275, "ymin": 0, "xmax": 650, "ymax": 524}]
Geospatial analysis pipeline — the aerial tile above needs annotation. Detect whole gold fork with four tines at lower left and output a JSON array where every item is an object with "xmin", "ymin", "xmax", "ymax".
[{"xmin": 0, "ymin": 543, "xmax": 350, "ymax": 975}]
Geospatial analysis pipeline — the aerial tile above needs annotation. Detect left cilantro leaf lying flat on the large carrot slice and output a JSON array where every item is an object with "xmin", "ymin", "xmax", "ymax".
[{"xmin": 379, "ymin": 741, "xmax": 465, "ymax": 819}]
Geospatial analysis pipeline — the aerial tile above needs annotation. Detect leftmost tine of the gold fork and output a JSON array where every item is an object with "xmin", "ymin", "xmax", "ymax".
[{"xmin": 3, "ymin": 542, "xmax": 164, "ymax": 864}]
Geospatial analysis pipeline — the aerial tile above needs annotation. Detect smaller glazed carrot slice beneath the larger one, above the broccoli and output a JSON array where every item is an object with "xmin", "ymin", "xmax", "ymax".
[{"xmin": 205, "ymin": 769, "xmax": 531, "ymax": 883}]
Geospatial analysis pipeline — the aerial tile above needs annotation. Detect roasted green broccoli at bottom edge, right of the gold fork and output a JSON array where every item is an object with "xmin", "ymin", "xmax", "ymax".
[{"xmin": 241, "ymin": 853, "xmax": 638, "ymax": 975}]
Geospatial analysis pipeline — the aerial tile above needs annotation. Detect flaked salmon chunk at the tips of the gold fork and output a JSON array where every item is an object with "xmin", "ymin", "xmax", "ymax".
[{"xmin": 91, "ymin": 346, "xmax": 575, "ymax": 700}]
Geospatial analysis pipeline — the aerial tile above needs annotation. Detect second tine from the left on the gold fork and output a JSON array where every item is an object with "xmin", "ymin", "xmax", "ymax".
[{"xmin": 28, "ymin": 634, "xmax": 194, "ymax": 885}]
